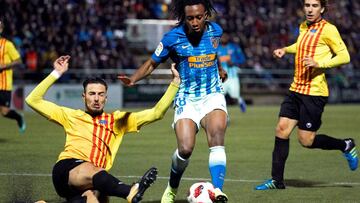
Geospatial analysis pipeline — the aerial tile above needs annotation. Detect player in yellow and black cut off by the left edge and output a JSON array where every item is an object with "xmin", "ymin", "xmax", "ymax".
[{"xmin": 0, "ymin": 20, "xmax": 26, "ymax": 133}]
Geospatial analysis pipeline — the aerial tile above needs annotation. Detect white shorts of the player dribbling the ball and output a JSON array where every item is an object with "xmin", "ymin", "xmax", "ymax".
[{"xmin": 172, "ymin": 93, "xmax": 228, "ymax": 130}]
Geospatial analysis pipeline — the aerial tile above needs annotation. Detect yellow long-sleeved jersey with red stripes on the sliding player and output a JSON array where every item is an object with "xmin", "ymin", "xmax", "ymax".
[{"xmin": 26, "ymin": 71, "xmax": 178, "ymax": 170}]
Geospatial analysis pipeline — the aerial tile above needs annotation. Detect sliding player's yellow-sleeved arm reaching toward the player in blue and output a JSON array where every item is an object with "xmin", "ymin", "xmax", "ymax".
[{"xmin": 135, "ymin": 64, "xmax": 181, "ymax": 128}]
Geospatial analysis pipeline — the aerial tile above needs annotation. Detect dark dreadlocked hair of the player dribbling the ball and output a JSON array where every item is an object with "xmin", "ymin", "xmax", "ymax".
[{"xmin": 171, "ymin": 0, "xmax": 216, "ymax": 24}]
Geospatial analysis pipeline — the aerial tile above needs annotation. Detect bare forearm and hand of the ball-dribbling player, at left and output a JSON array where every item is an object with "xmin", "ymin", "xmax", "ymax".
[{"xmin": 118, "ymin": 58, "xmax": 159, "ymax": 87}]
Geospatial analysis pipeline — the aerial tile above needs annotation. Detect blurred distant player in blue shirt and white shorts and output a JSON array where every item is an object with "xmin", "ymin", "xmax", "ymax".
[{"xmin": 218, "ymin": 32, "xmax": 246, "ymax": 112}]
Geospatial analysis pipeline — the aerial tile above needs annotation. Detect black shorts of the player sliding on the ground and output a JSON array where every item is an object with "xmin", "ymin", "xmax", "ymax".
[{"xmin": 52, "ymin": 159, "xmax": 85, "ymax": 200}]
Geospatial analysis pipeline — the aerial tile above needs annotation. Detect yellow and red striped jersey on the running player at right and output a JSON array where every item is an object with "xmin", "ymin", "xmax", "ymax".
[{"xmin": 286, "ymin": 19, "xmax": 350, "ymax": 97}]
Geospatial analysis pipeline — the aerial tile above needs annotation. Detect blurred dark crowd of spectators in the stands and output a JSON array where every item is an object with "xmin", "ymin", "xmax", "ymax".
[{"xmin": 0, "ymin": 0, "xmax": 360, "ymax": 81}]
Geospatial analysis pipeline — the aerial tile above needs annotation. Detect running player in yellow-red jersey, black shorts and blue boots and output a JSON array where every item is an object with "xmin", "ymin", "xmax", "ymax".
[{"xmin": 255, "ymin": 0, "xmax": 358, "ymax": 190}]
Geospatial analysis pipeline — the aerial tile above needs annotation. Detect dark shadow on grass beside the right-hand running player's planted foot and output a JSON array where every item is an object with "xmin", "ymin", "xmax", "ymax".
[{"xmin": 285, "ymin": 179, "xmax": 353, "ymax": 188}]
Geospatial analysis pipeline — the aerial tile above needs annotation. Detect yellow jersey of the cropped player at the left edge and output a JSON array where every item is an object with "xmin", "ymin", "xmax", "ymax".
[{"xmin": 0, "ymin": 38, "xmax": 20, "ymax": 91}]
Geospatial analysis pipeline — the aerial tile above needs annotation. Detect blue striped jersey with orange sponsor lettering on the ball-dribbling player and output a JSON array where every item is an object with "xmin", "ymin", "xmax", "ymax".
[{"xmin": 152, "ymin": 22, "xmax": 223, "ymax": 99}]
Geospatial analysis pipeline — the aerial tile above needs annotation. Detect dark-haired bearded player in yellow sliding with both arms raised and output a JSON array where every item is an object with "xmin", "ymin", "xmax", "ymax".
[{"xmin": 26, "ymin": 56, "xmax": 180, "ymax": 203}]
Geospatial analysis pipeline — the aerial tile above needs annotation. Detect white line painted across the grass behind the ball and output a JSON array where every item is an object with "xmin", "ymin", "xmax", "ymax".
[{"xmin": 0, "ymin": 173, "xmax": 360, "ymax": 185}]
